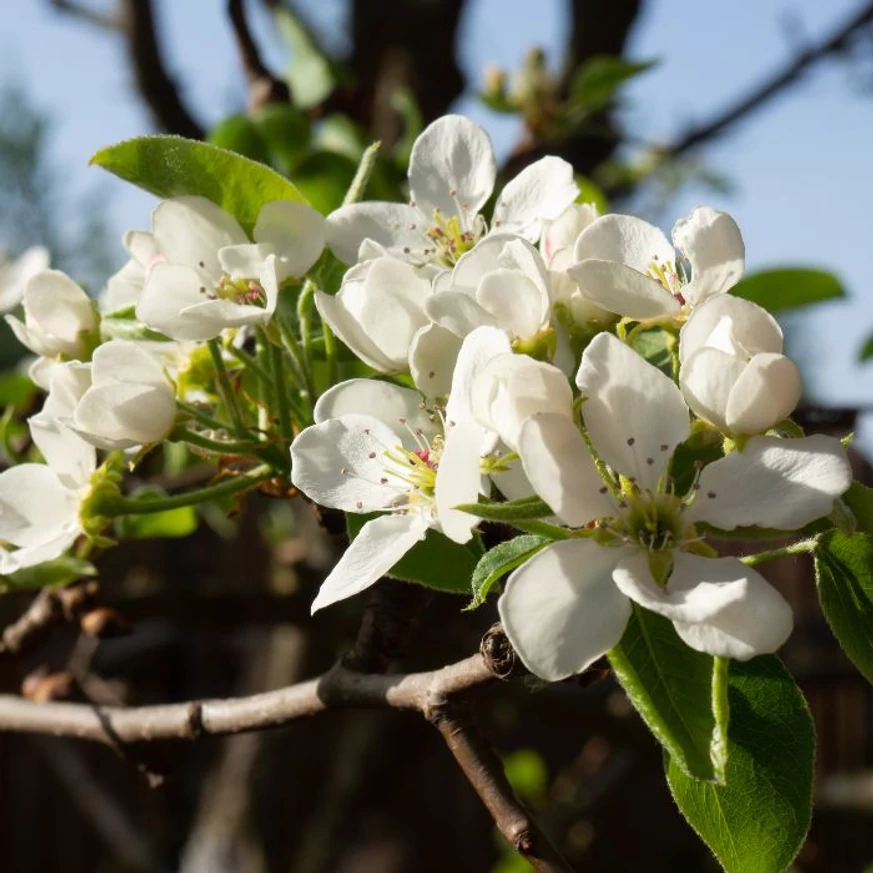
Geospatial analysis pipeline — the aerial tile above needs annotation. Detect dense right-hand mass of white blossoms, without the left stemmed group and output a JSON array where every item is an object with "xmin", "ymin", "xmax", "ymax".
[{"xmin": 292, "ymin": 116, "xmax": 851, "ymax": 680}]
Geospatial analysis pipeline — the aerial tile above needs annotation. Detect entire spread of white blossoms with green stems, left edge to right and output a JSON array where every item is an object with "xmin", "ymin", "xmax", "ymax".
[{"xmin": 0, "ymin": 110, "xmax": 851, "ymax": 680}]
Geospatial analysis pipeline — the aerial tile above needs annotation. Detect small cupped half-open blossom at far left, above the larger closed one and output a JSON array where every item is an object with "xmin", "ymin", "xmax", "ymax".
[{"xmin": 6, "ymin": 270, "xmax": 98, "ymax": 358}]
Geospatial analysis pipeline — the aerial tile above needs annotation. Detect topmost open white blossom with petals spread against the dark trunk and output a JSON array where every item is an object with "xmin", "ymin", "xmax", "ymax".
[{"xmin": 327, "ymin": 115, "xmax": 579, "ymax": 267}]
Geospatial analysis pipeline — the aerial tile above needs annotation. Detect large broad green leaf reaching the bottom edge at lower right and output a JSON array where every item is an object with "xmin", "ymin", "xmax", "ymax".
[{"xmin": 667, "ymin": 655, "xmax": 815, "ymax": 873}]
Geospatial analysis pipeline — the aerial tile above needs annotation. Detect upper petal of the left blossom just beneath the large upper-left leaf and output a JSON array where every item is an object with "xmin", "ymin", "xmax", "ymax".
[{"xmin": 152, "ymin": 197, "xmax": 249, "ymax": 279}]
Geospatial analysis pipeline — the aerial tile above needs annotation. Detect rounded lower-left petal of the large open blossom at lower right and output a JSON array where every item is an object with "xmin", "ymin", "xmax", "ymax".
[{"xmin": 497, "ymin": 540, "xmax": 631, "ymax": 682}]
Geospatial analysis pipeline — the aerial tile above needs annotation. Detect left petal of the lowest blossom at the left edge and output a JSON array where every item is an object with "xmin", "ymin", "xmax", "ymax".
[{"xmin": 0, "ymin": 464, "xmax": 79, "ymax": 547}]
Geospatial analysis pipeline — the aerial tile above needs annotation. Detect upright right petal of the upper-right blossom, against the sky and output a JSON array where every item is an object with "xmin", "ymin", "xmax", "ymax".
[{"xmin": 673, "ymin": 206, "xmax": 746, "ymax": 306}]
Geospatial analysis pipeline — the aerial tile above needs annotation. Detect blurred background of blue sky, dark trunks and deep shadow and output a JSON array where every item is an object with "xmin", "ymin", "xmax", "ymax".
[{"xmin": 0, "ymin": 0, "xmax": 873, "ymax": 873}]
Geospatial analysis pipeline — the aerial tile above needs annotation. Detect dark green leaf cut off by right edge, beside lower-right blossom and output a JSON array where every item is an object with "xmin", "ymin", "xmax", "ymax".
[{"xmin": 814, "ymin": 531, "xmax": 873, "ymax": 682}]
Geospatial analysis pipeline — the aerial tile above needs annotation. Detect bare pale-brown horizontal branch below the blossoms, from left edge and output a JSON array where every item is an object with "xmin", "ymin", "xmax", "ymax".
[{"xmin": 0, "ymin": 655, "xmax": 495, "ymax": 746}]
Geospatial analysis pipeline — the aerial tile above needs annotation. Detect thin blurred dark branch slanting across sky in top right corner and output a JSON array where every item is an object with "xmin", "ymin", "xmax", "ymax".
[{"xmin": 663, "ymin": 3, "xmax": 873, "ymax": 158}]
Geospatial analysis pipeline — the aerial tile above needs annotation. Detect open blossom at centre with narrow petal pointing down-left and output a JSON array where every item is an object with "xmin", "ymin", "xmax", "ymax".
[{"xmin": 291, "ymin": 331, "xmax": 503, "ymax": 612}]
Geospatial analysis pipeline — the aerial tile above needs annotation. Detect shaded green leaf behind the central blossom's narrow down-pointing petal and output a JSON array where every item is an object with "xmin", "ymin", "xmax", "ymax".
[{"xmin": 346, "ymin": 512, "xmax": 481, "ymax": 594}]
